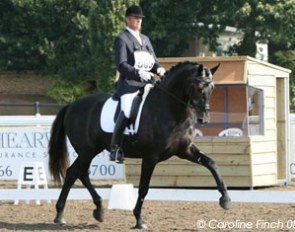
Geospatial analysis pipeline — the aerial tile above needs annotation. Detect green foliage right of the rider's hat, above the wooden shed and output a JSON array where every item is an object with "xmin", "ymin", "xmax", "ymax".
[{"xmin": 141, "ymin": 0, "xmax": 295, "ymax": 56}]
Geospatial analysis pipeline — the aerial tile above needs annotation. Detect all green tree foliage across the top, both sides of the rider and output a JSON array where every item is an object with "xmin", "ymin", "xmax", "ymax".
[{"xmin": 0, "ymin": 0, "xmax": 295, "ymax": 101}]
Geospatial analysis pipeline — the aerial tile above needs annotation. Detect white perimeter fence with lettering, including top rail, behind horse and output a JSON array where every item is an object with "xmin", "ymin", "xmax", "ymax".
[{"xmin": 0, "ymin": 114, "xmax": 295, "ymax": 180}]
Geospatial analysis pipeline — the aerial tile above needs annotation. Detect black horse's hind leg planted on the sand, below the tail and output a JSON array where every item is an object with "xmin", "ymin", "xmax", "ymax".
[{"xmin": 54, "ymin": 159, "xmax": 79, "ymax": 224}]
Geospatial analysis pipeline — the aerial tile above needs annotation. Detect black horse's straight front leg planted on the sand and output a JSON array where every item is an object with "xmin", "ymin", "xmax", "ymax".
[{"xmin": 133, "ymin": 159, "xmax": 157, "ymax": 229}]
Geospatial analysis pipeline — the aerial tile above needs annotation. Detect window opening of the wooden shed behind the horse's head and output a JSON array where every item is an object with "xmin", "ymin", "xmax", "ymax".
[{"xmin": 196, "ymin": 84, "xmax": 264, "ymax": 136}]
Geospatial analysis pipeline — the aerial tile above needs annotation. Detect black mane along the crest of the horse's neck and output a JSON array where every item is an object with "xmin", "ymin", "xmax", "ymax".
[{"xmin": 162, "ymin": 61, "xmax": 203, "ymax": 86}]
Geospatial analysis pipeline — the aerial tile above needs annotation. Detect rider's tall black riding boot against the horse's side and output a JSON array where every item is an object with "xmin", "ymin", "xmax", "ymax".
[{"xmin": 110, "ymin": 111, "xmax": 128, "ymax": 163}]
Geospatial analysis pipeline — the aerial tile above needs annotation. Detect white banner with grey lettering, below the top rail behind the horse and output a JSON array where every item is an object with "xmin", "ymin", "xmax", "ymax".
[{"xmin": 0, "ymin": 127, "xmax": 124, "ymax": 180}]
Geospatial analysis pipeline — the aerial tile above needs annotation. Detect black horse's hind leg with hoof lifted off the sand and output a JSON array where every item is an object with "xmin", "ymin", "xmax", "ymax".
[{"xmin": 79, "ymin": 160, "xmax": 103, "ymax": 222}]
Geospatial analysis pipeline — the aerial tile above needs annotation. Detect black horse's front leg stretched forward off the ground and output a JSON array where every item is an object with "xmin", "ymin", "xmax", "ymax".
[{"xmin": 179, "ymin": 144, "xmax": 231, "ymax": 210}]
